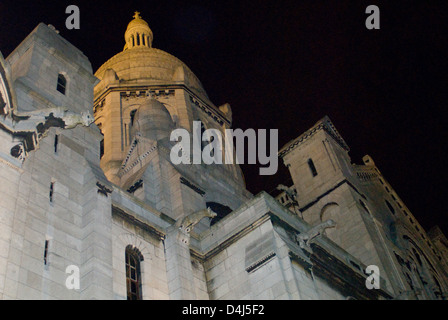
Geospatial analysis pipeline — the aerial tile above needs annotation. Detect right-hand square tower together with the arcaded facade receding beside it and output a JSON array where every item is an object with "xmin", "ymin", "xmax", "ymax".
[{"xmin": 279, "ymin": 117, "xmax": 443, "ymax": 299}]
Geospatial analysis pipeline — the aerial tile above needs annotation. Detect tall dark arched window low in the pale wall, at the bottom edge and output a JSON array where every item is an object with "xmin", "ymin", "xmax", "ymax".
[{"xmin": 126, "ymin": 245, "xmax": 143, "ymax": 300}]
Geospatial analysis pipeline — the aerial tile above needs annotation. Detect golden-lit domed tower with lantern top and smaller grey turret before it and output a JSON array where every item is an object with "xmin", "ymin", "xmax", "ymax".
[{"xmin": 94, "ymin": 12, "xmax": 252, "ymax": 224}]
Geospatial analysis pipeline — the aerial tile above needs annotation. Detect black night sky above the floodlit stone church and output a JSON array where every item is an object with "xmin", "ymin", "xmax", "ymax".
[{"xmin": 0, "ymin": 0, "xmax": 448, "ymax": 235}]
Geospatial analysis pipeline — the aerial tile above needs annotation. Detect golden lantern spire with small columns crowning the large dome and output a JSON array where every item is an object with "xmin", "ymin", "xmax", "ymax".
[{"xmin": 124, "ymin": 11, "xmax": 153, "ymax": 50}]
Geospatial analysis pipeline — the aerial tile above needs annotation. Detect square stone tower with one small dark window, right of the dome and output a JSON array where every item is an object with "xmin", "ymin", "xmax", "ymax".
[{"xmin": 279, "ymin": 117, "xmax": 388, "ymax": 280}]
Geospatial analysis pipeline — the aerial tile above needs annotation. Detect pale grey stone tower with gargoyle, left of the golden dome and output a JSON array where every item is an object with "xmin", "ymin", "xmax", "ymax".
[{"xmin": 0, "ymin": 23, "xmax": 112, "ymax": 299}]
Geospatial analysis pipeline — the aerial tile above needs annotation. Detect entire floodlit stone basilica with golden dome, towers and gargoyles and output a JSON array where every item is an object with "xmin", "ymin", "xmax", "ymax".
[{"xmin": 0, "ymin": 12, "xmax": 448, "ymax": 300}]
